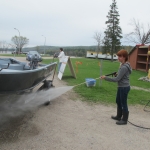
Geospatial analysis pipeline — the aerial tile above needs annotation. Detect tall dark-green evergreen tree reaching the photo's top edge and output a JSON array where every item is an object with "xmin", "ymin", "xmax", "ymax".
[{"xmin": 104, "ymin": 0, "xmax": 122, "ymax": 61}]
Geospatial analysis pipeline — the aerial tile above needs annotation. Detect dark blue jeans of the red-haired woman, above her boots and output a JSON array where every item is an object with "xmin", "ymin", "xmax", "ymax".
[{"xmin": 116, "ymin": 86, "xmax": 130, "ymax": 112}]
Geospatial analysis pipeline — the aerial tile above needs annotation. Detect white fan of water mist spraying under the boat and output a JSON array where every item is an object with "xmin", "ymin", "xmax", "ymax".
[{"xmin": 0, "ymin": 86, "xmax": 73, "ymax": 124}]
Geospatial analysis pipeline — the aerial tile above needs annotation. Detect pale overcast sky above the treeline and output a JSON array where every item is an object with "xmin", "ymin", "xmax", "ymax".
[{"xmin": 0, "ymin": 0, "xmax": 150, "ymax": 46}]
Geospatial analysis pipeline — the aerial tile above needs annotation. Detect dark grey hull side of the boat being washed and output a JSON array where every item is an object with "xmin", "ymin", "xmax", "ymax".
[{"xmin": 0, "ymin": 63, "xmax": 57, "ymax": 93}]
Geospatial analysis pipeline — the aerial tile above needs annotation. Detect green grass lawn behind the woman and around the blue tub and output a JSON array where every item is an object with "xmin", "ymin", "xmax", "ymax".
[{"xmin": 43, "ymin": 58, "xmax": 150, "ymax": 104}]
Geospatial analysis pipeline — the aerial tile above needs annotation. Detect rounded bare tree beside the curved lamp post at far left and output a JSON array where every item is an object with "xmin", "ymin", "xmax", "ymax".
[{"xmin": 11, "ymin": 36, "xmax": 29, "ymax": 53}]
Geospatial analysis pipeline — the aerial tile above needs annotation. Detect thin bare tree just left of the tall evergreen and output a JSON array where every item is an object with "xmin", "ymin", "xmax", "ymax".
[{"xmin": 93, "ymin": 31, "xmax": 103, "ymax": 58}]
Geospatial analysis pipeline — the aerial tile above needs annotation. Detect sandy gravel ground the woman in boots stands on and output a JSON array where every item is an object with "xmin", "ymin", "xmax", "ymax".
[{"xmin": 0, "ymin": 56, "xmax": 150, "ymax": 150}]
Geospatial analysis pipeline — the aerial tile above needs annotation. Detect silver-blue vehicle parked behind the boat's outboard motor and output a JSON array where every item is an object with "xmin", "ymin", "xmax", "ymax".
[{"xmin": 26, "ymin": 51, "xmax": 42, "ymax": 62}]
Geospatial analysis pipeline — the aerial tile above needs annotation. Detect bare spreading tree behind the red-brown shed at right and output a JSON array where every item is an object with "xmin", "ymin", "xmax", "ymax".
[{"xmin": 126, "ymin": 19, "xmax": 150, "ymax": 44}]
